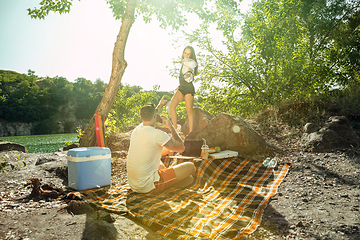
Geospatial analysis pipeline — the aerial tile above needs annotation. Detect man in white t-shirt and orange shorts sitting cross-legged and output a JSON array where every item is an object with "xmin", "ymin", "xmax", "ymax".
[{"xmin": 127, "ymin": 98, "xmax": 196, "ymax": 193}]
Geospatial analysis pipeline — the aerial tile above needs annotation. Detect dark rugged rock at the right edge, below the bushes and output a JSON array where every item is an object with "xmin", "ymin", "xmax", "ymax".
[{"xmin": 300, "ymin": 116, "xmax": 360, "ymax": 152}]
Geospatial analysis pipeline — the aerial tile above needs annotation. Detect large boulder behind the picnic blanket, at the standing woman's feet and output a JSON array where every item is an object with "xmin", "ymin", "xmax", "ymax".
[{"xmin": 186, "ymin": 113, "xmax": 269, "ymax": 159}]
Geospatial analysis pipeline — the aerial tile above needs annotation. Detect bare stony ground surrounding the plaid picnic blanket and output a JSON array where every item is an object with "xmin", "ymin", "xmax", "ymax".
[{"xmin": 0, "ymin": 123, "xmax": 360, "ymax": 240}]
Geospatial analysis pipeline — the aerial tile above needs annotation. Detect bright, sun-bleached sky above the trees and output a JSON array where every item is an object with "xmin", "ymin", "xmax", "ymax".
[{"xmin": 0, "ymin": 0, "xmax": 251, "ymax": 91}]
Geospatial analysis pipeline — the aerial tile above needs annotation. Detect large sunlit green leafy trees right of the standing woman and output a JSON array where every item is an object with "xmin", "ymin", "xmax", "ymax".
[{"xmin": 187, "ymin": 0, "xmax": 360, "ymax": 117}]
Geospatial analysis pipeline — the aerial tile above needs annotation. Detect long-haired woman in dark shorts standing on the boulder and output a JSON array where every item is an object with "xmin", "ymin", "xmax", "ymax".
[{"xmin": 170, "ymin": 46, "xmax": 198, "ymax": 132}]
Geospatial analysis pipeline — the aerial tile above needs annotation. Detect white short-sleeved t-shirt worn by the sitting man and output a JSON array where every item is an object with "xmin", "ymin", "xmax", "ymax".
[{"xmin": 126, "ymin": 124, "xmax": 171, "ymax": 193}]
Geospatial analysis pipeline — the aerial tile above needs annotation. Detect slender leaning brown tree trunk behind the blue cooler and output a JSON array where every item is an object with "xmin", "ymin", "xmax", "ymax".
[{"xmin": 80, "ymin": 0, "xmax": 136, "ymax": 147}]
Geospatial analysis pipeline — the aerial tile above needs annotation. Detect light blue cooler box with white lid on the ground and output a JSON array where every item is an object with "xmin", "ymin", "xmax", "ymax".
[{"xmin": 66, "ymin": 147, "xmax": 111, "ymax": 190}]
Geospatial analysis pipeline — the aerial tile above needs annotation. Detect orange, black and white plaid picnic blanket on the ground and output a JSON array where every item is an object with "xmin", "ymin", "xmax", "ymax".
[{"xmin": 85, "ymin": 157, "xmax": 290, "ymax": 239}]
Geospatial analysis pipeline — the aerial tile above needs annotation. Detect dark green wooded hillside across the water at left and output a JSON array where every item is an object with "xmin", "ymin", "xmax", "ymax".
[{"xmin": 0, "ymin": 70, "xmax": 107, "ymax": 134}]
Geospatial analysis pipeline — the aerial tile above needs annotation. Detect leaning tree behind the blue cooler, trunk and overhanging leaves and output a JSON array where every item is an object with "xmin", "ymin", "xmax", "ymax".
[{"xmin": 28, "ymin": 0, "xmax": 238, "ymax": 146}]
